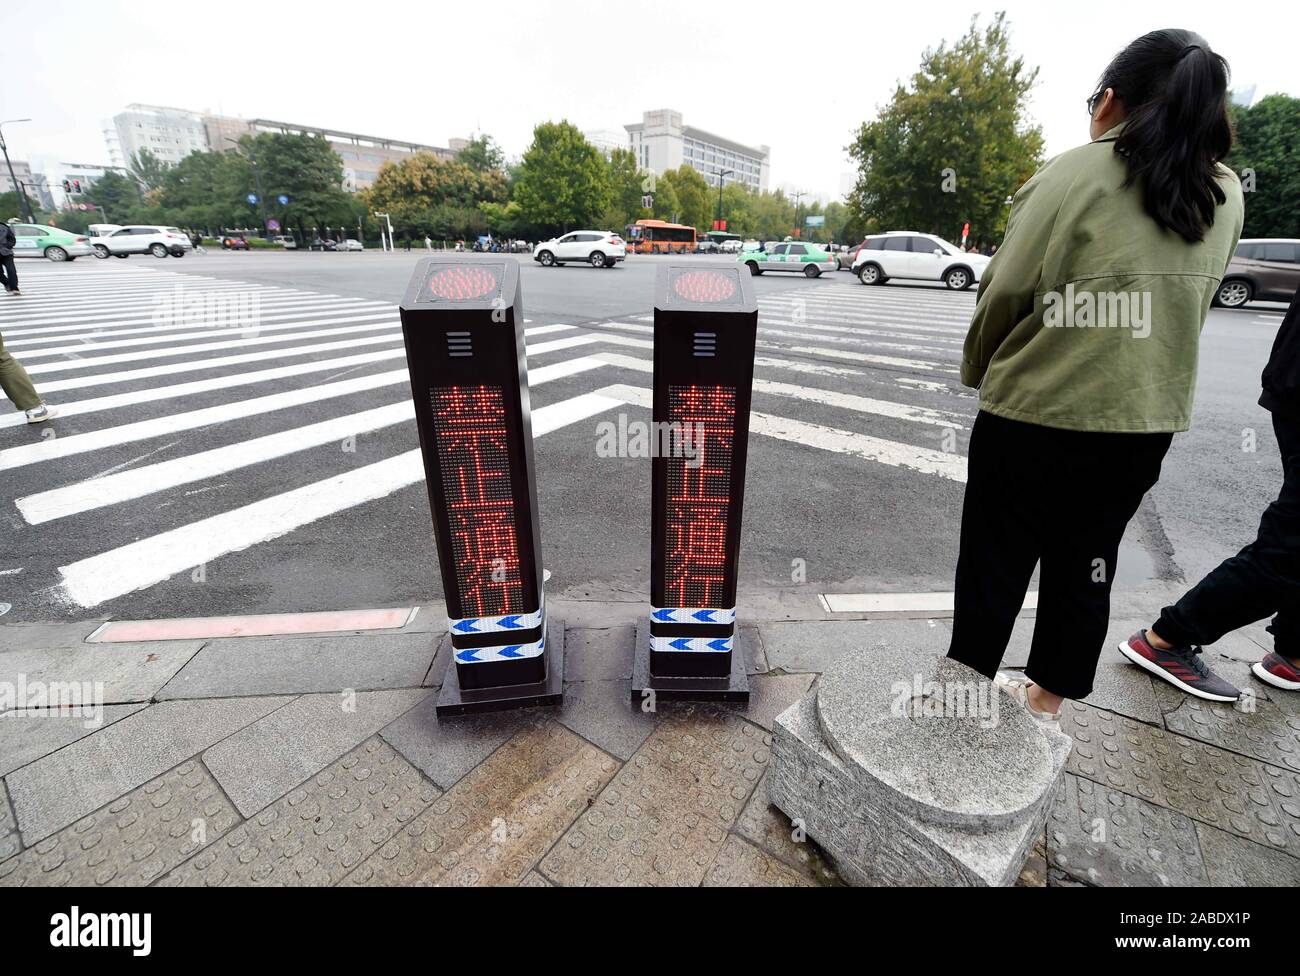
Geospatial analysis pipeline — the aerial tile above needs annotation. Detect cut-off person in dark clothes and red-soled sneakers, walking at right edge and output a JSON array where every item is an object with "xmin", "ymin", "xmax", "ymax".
[{"xmin": 1119, "ymin": 292, "xmax": 1300, "ymax": 702}]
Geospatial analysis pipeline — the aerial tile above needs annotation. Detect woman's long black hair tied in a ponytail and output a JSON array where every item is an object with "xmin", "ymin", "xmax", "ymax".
[{"xmin": 1097, "ymin": 29, "xmax": 1232, "ymax": 242}]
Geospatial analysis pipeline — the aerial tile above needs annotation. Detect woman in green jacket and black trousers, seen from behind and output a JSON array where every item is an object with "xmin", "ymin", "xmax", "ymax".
[{"xmin": 948, "ymin": 30, "xmax": 1243, "ymax": 721}]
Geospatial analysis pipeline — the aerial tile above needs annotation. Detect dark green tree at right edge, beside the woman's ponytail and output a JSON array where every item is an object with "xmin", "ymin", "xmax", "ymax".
[{"xmin": 1226, "ymin": 95, "xmax": 1300, "ymax": 238}]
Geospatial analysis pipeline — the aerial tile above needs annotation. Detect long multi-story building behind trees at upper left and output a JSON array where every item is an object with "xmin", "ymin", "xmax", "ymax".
[{"xmin": 104, "ymin": 105, "xmax": 467, "ymax": 191}]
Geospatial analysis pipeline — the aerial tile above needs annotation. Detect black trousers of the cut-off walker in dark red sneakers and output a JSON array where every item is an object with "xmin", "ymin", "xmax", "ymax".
[{"xmin": 1156, "ymin": 413, "xmax": 1300, "ymax": 658}]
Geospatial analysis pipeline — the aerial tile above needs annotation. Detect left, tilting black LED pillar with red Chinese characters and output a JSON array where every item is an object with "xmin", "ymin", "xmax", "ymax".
[{"xmin": 402, "ymin": 257, "xmax": 564, "ymax": 716}]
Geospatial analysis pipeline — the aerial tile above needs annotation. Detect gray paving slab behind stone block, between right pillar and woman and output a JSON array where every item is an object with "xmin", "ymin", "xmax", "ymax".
[{"xmin": 759, "ymin": 620, "xmax": 952, "ymax": 673}]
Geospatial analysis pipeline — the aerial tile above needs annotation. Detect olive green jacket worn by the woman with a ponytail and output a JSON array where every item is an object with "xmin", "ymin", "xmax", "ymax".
[{"xmin": 962, "ymin": 126, "xmax": 1244, "ymax": 433}]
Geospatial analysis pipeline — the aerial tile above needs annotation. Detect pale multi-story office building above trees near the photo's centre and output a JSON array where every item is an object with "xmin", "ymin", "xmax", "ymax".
[{"xmin": 623, "ymin": 108, "xmax": 771, "ymax": 190}]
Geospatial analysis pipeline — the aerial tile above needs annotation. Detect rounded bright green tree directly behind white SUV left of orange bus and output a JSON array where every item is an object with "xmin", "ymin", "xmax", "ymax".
[{"xmin": 514, "ymin": 121, "xmax": 610, "ymax": 230}]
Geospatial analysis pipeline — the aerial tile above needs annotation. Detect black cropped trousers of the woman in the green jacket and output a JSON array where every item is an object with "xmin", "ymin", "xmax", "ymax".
[{"xmin": 948, "ymin": 411, "xmax": 1174, "ymax": 698}]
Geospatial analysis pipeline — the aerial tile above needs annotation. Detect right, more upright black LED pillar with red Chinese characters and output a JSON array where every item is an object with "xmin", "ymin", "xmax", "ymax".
[{"xmin": 632, "ymin": 265, "xmax": 758, "ymax": 702}]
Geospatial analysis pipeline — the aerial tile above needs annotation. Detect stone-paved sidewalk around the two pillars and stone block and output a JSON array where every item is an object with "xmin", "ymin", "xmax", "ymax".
[{"xmin": 0, "ymin": 593, "xmax": 1300, "ymax": 886}]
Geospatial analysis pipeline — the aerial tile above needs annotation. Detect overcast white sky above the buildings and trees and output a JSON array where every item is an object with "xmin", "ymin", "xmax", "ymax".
[{"xmin": 0, "ymin": 0, "xmax": 1300, "ymax": 196}]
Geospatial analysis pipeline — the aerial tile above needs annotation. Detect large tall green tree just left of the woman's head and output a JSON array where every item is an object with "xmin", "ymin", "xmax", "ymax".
[{"xmin": 848, "ymin": 13, "xmax": 1043, "ymax": 244}]
